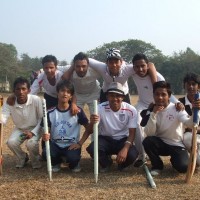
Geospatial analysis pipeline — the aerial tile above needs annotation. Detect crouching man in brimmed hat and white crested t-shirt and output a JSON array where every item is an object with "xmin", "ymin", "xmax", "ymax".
[{"xmin": 87, "ymin": 82, "xmax": 138, "ymax": 172}]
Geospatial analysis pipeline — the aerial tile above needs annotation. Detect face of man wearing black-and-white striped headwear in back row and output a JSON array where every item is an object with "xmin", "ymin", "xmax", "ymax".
[{"xmin": 107, "ymin": 58, "xmax": 122, "ymax": 76}]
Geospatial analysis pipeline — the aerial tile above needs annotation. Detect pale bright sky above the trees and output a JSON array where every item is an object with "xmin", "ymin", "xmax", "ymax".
[{"xmin": 0, "ymin": 0, "xmax": 200, "ymax": 62}]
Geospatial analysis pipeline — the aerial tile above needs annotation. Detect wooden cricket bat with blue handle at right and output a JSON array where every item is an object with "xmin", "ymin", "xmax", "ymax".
[{"xmin": 185, "ymin": 93, "xmax": 199, "ymax": 183}]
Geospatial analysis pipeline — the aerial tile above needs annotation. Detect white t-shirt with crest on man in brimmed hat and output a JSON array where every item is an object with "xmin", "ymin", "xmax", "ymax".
[{"xmin": 98, "ymin": 101, "xmax": 137, "ymax": 140}]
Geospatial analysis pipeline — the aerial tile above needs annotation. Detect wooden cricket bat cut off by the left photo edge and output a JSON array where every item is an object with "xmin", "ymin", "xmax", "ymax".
[{"xmin": 0, "ymin": 96, "xmax": 3, "ymax": 175}]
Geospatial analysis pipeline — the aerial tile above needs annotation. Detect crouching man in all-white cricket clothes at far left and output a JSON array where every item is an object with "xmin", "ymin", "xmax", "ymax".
[{"xmin": 2, "ymin": 77, "xmax": 43, "ymax": 169}]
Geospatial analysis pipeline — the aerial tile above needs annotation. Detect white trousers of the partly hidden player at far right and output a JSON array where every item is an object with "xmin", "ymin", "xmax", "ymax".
[{"xmin": 183, "ymin": 132, "xmax": 200, "ymax": 166}]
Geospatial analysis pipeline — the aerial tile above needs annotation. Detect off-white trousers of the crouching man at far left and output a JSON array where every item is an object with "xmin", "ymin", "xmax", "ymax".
[{"xmin": 7, "ymin": 128, "xmax": 41, "ymax": 168}]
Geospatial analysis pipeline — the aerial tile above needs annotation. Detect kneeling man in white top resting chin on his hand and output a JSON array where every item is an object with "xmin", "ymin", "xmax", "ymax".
[{"xmin": 141, "ymin": 81, "xmax": 193, "ymax": 175}]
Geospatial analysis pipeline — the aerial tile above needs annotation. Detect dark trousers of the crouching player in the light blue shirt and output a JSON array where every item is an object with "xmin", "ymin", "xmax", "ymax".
[{"xmin": 42, "ymin": 142, "xmax": 81, "ymax": 169}]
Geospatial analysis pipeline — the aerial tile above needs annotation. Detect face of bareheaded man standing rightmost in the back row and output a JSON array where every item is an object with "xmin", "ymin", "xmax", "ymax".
[{"xmin": 133, "ymin": 59, "xmax": 148, "ymax": 77}]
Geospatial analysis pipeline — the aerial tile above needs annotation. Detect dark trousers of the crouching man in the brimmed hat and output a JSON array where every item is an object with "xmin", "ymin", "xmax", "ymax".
[{"xmin": 86, "ymin": 135, "xmax": 138, "ymax": 168}]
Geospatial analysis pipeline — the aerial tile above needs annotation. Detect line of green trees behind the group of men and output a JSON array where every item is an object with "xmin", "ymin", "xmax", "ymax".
[{"xmin": 0, "ymin": 39, "xmax": 200, "ymax": 94}]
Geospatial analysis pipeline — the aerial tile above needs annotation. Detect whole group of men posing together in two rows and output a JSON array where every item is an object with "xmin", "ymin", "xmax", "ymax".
[{"xmin": 1, "ymin": 48, "xmax": 200, "ymax": 175}]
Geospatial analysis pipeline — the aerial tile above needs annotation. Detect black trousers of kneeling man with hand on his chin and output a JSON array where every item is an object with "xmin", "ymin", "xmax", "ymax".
[{"xmin": 143, "ymin": 136, "xmax": 189, "ymax": 173}]
